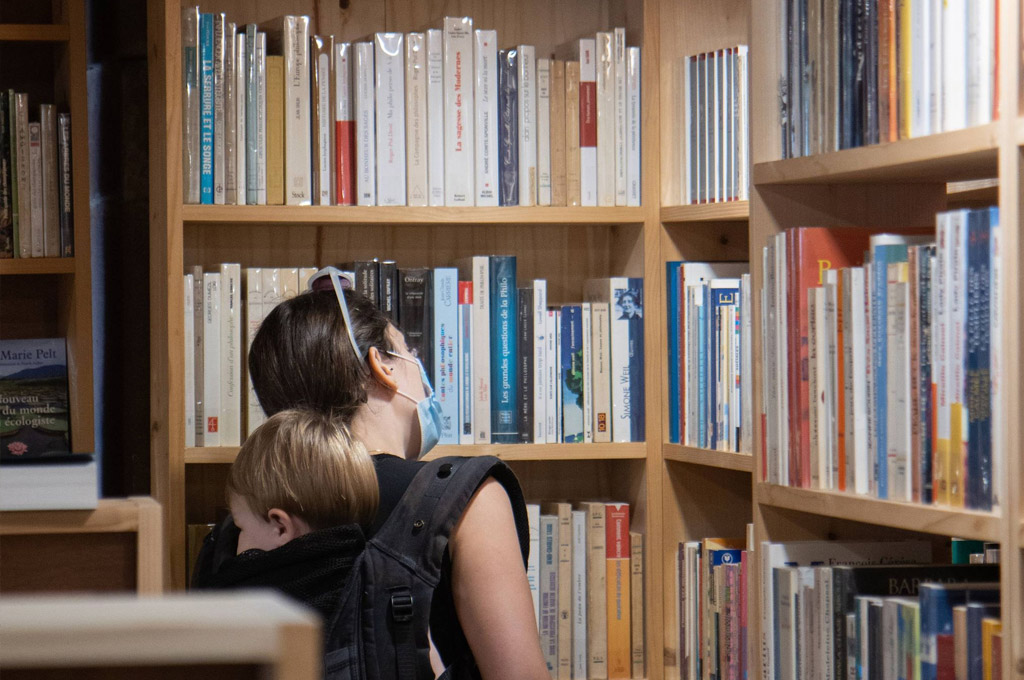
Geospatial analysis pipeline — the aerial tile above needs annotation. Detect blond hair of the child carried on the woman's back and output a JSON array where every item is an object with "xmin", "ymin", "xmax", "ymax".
[{"xmin": 227, "ymin": 409, "xmax": 380, "ymax": 530}]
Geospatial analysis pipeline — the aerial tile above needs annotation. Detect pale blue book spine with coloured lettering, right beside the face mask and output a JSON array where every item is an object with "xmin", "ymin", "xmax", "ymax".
[{"xmin": 433, "ymin": 267, "xmax": 460, "ymax": 443}]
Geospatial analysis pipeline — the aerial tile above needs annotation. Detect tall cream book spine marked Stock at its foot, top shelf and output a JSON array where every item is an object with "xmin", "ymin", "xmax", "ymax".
[{"xmin": 283, "ymin": 16, "xmax": 312, "ymax": 206}]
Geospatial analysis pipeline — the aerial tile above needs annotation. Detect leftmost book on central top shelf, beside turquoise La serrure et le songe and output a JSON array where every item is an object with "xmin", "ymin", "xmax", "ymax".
[{"xmin": 181, "ymin": 5, "xmax": 202, "ymax": 204}]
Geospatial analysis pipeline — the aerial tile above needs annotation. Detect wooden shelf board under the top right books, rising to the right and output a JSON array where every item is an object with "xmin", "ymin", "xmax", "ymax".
[{"xmin": 754, "ymin": 123, "xmax": 999, "ymax": 184}]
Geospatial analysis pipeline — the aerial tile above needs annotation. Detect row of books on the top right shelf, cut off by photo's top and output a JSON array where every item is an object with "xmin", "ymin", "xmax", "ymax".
[{"xmin": 779, "ymin": 0, "xmax": 998, "ymax": 158}]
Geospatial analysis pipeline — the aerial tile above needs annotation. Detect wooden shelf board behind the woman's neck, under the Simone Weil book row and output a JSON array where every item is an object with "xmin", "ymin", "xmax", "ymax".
[{"xmin": 185, "ymin": 441, "xmax": 647, "ymax": 465}]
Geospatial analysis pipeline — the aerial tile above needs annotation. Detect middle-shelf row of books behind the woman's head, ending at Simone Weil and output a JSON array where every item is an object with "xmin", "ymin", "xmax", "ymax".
[{"xmin": 183, "ymin": 256, "xmax": 645, "ymax": 447}]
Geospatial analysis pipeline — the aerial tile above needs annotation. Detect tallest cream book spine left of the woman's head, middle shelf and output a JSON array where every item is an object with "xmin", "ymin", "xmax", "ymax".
[{"xmin": 219, "ymin": 264, "xmax": 242, "ymax": 447}]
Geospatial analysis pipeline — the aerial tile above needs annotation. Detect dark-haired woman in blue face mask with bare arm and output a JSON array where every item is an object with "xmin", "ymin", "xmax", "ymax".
[{"xmin": 205, "ymin": 267, "xmax": 550, "ymax": 680}]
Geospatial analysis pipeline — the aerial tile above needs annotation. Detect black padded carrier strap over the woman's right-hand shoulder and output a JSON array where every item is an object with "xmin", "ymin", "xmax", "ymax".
[{"xmin": 372, "ymin": 456, "xmax": 529, "ymax": 586}]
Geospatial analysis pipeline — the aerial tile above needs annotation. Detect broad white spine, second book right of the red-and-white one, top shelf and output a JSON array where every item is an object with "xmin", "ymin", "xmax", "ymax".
[{"xmin": 374, "ymin": 33, "xmax": 406, "ymax": 206}]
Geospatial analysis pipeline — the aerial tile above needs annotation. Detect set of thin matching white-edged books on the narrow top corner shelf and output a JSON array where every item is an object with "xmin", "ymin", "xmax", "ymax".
[{"xmin": 679, "ymin": 45, "xmax": 751, "ymax": 204}]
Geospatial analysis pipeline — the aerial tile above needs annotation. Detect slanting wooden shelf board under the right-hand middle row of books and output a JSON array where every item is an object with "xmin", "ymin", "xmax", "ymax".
[{"xmin": 756, "ymin": 483, "xmax": 1001, "ymax": 541}]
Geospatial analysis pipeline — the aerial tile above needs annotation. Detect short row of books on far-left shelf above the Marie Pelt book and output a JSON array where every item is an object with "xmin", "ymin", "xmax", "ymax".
[{"xmin": 0, "ymin": 89, "xmax": 75, "ymax": 258}]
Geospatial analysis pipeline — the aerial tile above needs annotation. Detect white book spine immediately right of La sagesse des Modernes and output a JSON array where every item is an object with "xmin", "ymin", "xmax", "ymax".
[{"xmin": 473, "ymin": 29, "xmax": 498, "ymax": 206}]
